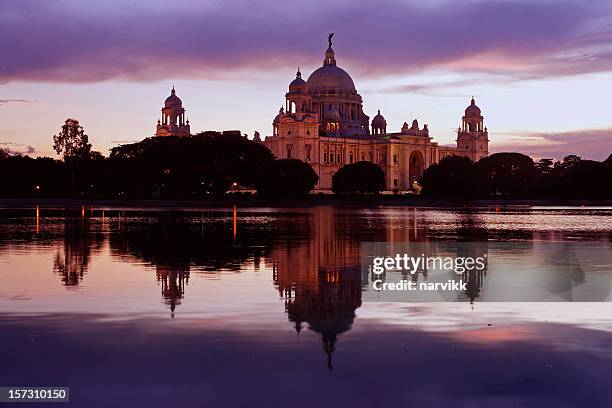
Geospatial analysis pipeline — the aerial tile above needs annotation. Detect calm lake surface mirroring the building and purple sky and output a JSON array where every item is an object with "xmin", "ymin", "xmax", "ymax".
[{"xmin": 0, "ymin": 207, "xmax": 612, "ymax": 407}]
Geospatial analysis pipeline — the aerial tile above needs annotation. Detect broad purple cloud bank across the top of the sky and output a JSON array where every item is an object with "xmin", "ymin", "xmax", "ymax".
[{"xmin": 0, "ymin": 0, "xmax": 612, "ymax": 82}]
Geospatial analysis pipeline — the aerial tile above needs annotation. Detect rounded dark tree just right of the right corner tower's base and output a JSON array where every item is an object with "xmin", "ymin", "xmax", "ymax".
[{"xmin": 475, "ymin": 153, "xmax": 536, "ymax": 198}]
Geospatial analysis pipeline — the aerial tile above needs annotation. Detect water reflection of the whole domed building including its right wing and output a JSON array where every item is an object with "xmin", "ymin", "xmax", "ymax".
[{"xmin": 270, "ymin": 207, "xmax": 488, "ymax": 369}]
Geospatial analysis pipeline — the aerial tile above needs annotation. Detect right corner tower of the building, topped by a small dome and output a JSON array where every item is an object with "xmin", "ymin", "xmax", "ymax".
[{"xmin": 457, "ymin": 97, "xmax": 489, "ymax": 162}]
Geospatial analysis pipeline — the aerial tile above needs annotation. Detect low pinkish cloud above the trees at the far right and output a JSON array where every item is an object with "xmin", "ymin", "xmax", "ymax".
[{"xmin": 490, "ymin": 128, "xmax": 612, "ymax": 161}]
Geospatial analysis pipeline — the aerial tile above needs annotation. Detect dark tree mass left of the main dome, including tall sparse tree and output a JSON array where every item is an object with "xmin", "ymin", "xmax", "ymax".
[{"xmin": 0, "ymin": 119, "xmax": 318, "ymax": 199}]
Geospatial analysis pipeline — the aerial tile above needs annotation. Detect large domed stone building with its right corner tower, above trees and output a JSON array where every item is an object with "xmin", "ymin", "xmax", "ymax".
[{"xmin": 262, "ymin": 35, "xmax": 489, "ymax": 192}]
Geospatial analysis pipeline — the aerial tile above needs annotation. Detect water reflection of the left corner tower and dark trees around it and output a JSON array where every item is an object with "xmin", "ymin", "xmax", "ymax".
[{"xmin": 109, "ymin": 209, "xmax": 274, "ymax": 317}]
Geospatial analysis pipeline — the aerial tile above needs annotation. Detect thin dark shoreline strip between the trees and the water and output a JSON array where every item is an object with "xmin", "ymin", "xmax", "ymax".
[{"xmin": 0, "ymin": 196, "xmax": 612, "ymax": 210}]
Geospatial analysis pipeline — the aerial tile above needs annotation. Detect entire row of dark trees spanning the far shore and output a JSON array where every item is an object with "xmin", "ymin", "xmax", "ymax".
[{"xmin": 0, "ymin": 119, "xmax": 612, "ymax": 200}]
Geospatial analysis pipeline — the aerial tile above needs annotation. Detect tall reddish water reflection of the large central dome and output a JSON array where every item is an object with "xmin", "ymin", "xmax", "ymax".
[{"xmin": 270, "ymin": 207, "xmax": 361, "ymax": 369}]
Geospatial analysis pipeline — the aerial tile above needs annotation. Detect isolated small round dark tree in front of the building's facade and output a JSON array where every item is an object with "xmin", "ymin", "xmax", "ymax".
[{"xmin": 332, "ymin": 161, "xmax": 386, "ymax": 194}]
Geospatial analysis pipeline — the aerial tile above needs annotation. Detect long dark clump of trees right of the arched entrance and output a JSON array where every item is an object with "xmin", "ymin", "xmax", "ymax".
[{"xmin": 421, "ymin": 153, "xmax": 612, "ymax": 200}]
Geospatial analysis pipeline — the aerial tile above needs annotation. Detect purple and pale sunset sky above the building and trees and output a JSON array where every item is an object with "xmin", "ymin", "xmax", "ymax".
[{"xmin": 0, "ymin": 0, "xmax": 612, "ymax": 160}]
